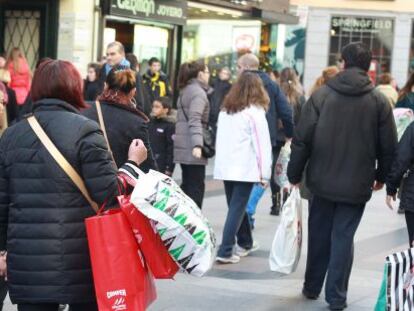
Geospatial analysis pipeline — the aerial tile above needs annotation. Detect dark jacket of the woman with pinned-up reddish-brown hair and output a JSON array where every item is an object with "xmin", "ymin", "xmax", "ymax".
[{"xmin": 82, "ymin": 102, "xmax": 157, "ymax": 173}]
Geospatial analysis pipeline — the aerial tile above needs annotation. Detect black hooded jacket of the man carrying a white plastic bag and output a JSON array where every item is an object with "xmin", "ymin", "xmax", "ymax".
[{"xmin": 288, "ymin": 68, "xmax": 397, "ymax": 204}]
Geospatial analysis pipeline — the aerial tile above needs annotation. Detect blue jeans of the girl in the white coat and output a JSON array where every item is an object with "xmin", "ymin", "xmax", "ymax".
[{"xmin": 217, "ymin": 181, "xmax": 253, "ymax": 258}]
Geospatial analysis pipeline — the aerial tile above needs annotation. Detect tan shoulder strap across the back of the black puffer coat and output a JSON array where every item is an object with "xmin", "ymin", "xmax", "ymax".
[{"xmin": 27, "ymin": 116, "xmax": 99, "ymax": 214}]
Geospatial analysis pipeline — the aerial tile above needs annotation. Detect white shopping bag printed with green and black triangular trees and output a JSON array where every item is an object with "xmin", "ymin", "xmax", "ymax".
[{"xmin": 131, "ymin": 170, "xmax": 216, "ymax": 276}]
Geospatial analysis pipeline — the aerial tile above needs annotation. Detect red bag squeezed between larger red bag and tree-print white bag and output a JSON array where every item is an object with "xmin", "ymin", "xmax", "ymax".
[{"xmin": 118, "ymin": 196, "xmax": 179, "ymax": 279}]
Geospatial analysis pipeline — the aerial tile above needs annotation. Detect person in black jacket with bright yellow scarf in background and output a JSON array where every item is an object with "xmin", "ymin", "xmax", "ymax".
[{"xmin": 143, "ymin": 57, "xmax": 171, "ymax": 102}]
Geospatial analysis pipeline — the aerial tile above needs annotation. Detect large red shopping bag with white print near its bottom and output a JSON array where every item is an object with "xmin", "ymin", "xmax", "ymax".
[{"xmin": 85, "ymin": 209, "xmax": 157, "ymax": 311}]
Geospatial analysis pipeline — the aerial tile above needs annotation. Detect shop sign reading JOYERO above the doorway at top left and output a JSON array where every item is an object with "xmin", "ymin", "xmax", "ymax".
[{"xmin": 110, "ymin": 0, "xmax": 187, "ymax": 25}]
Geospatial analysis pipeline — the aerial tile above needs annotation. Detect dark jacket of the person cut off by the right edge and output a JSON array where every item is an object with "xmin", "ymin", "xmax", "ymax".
[{"xmin": 387, "ymin": 123, "xmax": 414, "ymax": 212}]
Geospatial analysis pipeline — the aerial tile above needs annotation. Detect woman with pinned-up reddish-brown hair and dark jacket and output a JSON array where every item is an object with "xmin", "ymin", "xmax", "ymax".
[{"xmin": 83, "ymin": 65, "xmax": 156, "ymax": 172}]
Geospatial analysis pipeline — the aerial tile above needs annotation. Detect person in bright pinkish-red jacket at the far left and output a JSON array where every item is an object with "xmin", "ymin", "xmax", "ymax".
[{"xmin": 7, "ymin": 48, "xmax": 32, "ymax": 105}]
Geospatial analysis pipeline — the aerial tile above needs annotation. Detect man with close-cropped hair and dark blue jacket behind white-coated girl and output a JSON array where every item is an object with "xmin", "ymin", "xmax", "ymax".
[{"xmin": 237, "ymin": 53, "xmax": 293, "ymax": 215}]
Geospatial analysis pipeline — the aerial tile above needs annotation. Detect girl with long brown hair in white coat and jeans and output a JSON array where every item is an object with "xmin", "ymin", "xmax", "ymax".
[{"xmin": 214, "ymin": 72, "xmax": 272, "ymax": 263}]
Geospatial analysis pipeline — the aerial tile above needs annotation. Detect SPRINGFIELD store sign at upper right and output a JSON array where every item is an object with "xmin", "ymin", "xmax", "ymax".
[{"xmin": 331, "ymin": 17, "xmax": 394, "ymax": 33}]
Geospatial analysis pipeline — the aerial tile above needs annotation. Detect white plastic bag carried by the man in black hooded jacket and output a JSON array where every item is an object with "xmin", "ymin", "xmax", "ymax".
[{"xmin": 269, "ymin": 188, "xmax": 302, "ymax": 274}]
